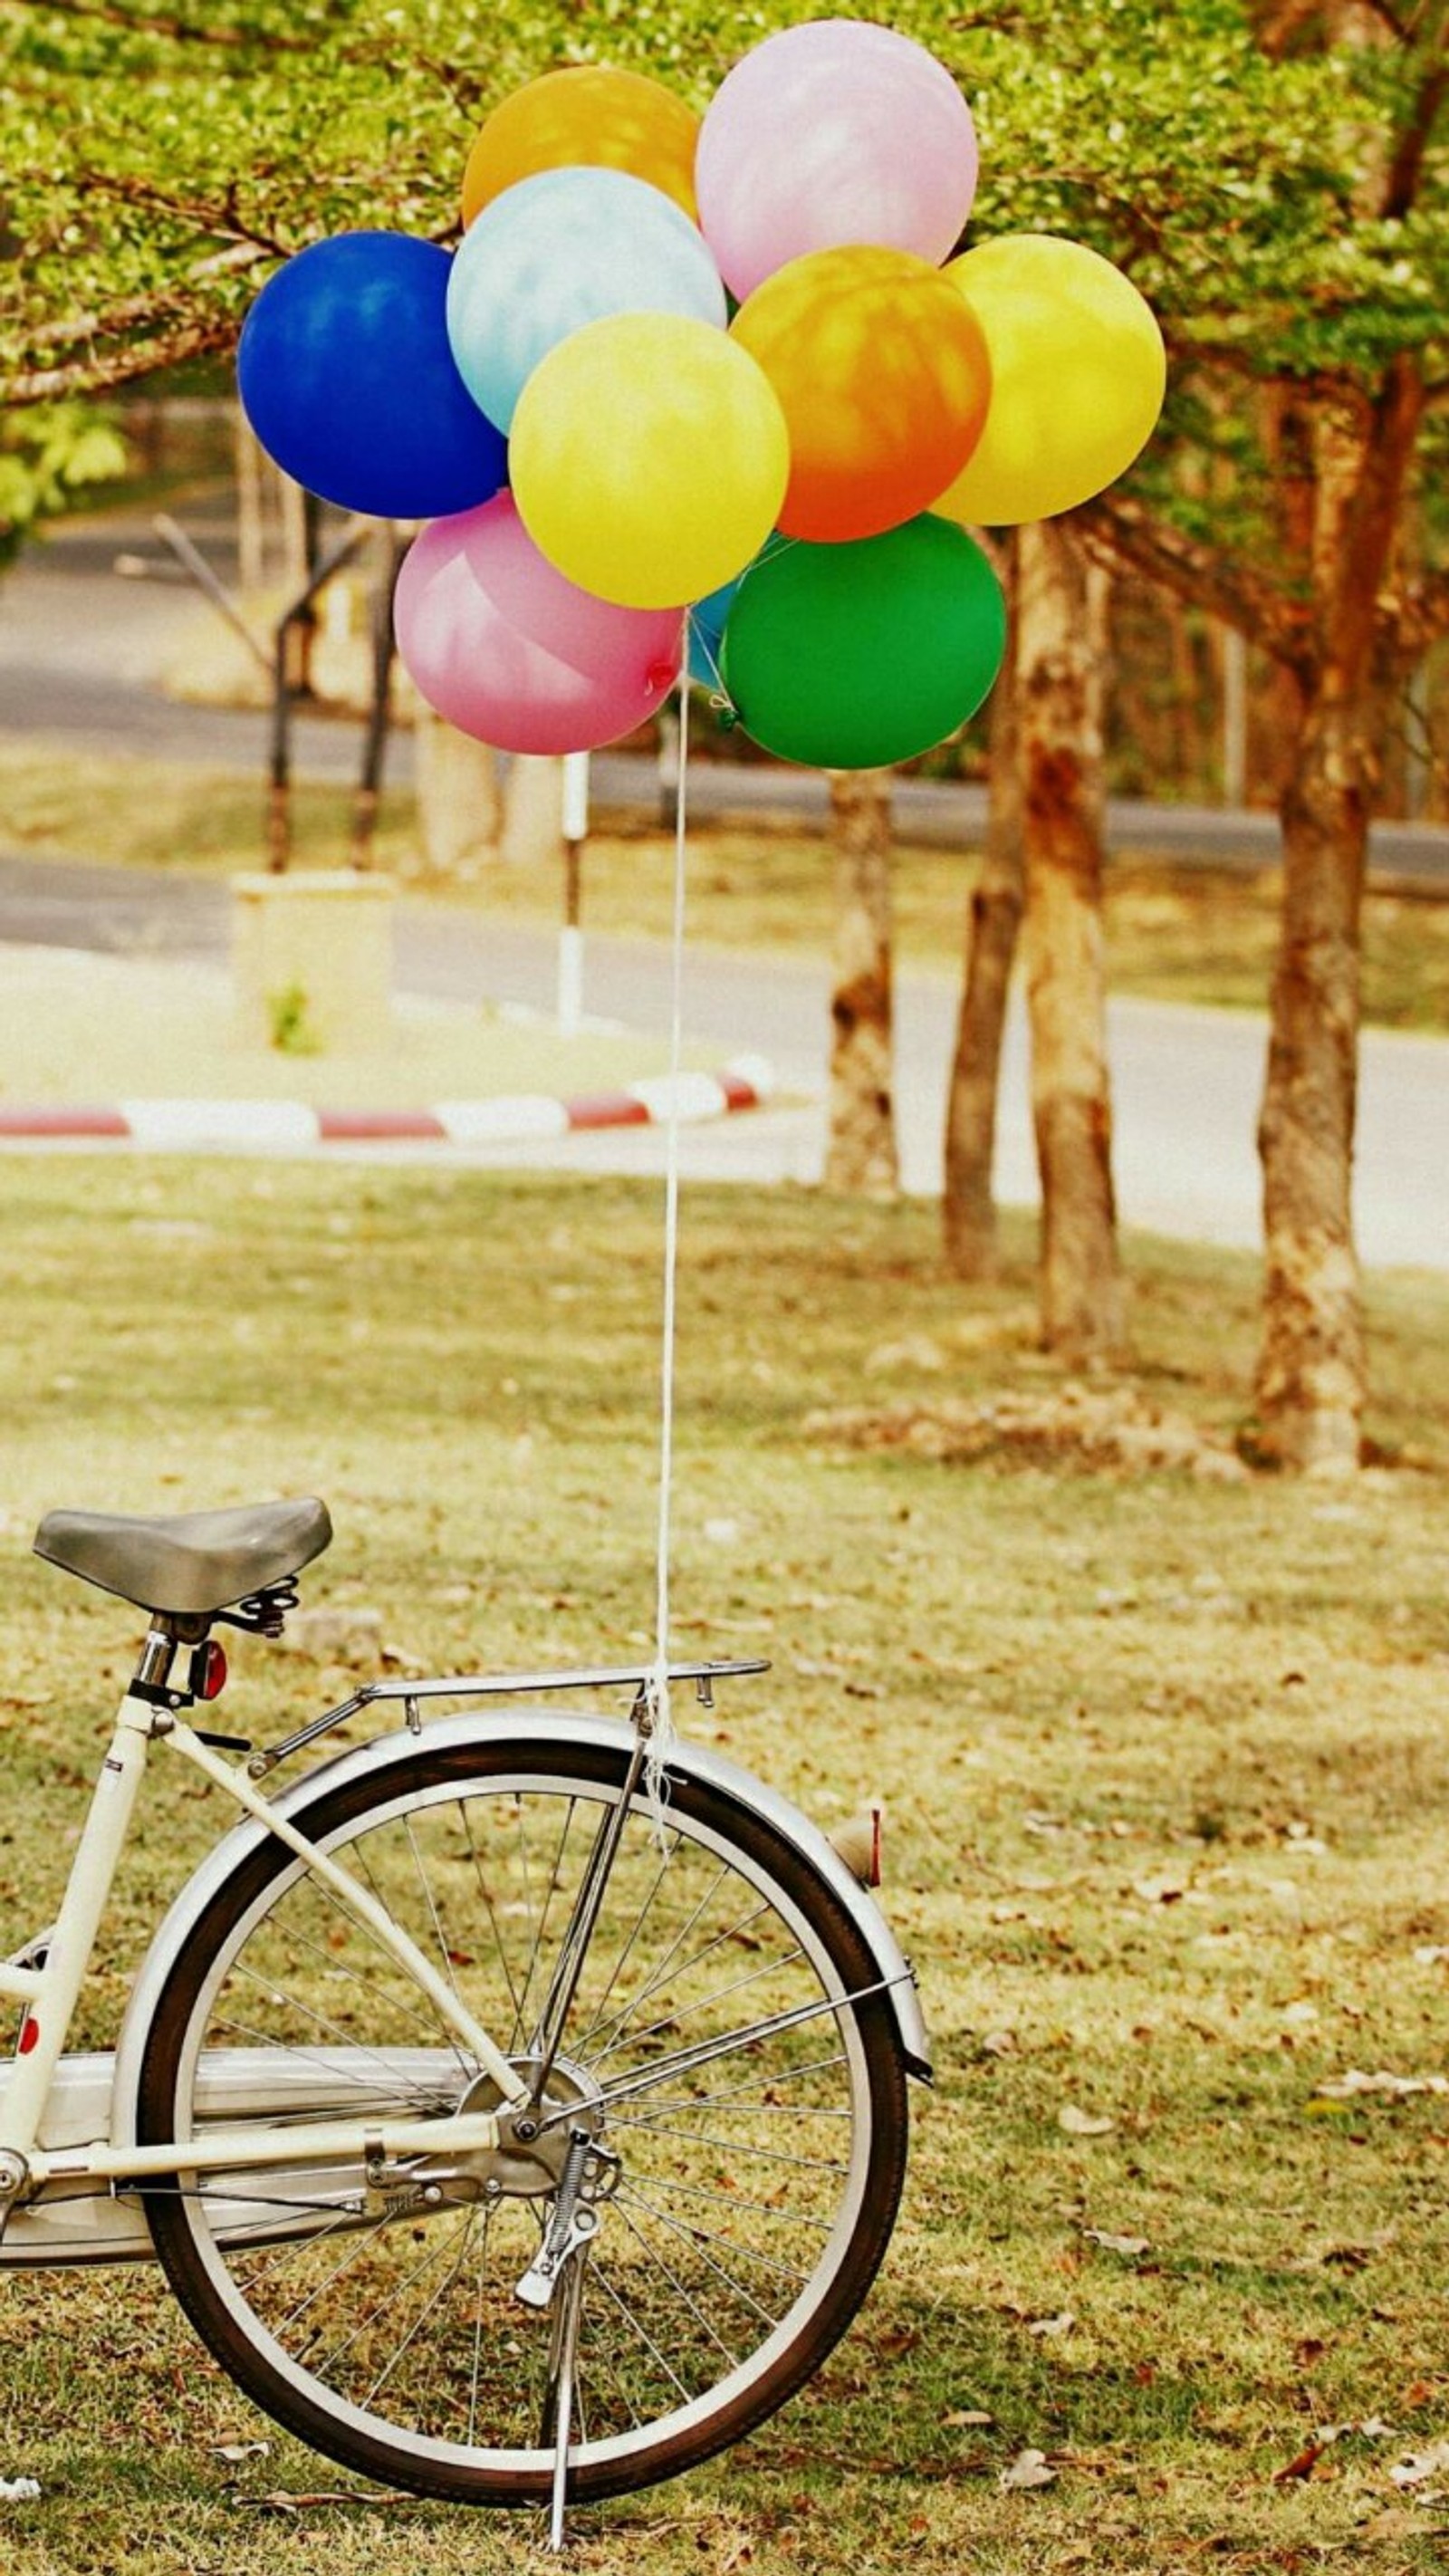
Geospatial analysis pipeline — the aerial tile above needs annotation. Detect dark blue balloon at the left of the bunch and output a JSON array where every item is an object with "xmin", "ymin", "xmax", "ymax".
[{"xmin": 236, "ymin": 232, "xmax": 507, "ymax": 518}]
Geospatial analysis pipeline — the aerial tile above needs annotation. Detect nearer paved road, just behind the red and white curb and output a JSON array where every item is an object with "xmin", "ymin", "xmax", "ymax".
[{"xmin": 0, "ymin": 860, "xmax": 1449, "ymax": 1270}]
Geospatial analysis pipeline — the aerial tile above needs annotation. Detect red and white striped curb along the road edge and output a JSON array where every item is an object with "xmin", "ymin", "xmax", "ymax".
[{"xmin": 0, "ymin": 1056, "xmax": 774, "ymax": 1154}]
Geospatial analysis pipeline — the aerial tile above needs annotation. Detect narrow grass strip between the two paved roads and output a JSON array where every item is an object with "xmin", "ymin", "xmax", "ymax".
[{"xmin": 0, "ymin": 742, "xmax": 1449, "ymax": 1031}]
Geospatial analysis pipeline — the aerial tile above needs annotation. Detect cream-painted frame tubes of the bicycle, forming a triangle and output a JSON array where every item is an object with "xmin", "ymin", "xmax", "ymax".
[{"xmin": 0, "ymin": 1693, "xmax": 528, "ymax": 2207}]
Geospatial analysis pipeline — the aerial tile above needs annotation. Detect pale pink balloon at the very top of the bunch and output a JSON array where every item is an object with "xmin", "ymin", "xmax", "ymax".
[{"xmin": 695, "ymin": 18, "xmax": 975, "ymax": 302}]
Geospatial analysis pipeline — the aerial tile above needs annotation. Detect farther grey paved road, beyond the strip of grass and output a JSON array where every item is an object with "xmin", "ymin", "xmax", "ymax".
[{"xmin": 0, "ymin": 503, "xmax": 1449, "ymax": 881}]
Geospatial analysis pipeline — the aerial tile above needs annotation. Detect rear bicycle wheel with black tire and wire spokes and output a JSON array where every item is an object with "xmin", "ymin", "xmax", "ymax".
[{"xmin": 137, "ymin": 1734, "xmax": 906, "ymax": 2504}]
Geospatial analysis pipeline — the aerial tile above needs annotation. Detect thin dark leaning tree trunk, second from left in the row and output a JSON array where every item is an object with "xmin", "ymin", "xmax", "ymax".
[{"xmin": 942, "ymin": 546, "xmax": 1027, "ymax": 1280}]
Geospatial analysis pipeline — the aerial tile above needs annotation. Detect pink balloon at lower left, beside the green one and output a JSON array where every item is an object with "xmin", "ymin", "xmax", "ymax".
[{"xmin": 394, "ymin": 492, "xmax": 682, "ymax": 752}]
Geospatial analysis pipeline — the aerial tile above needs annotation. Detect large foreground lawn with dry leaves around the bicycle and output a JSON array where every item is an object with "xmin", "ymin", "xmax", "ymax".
[{"xmin": 0, "ymin": 1159, "xmax": 1449, "ymax": 2576}]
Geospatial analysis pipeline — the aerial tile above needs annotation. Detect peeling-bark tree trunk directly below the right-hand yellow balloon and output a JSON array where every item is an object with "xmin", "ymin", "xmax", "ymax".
[{"xmin": 1017, "ymin": 520, "xmax": 1122, "ymax": 1360}]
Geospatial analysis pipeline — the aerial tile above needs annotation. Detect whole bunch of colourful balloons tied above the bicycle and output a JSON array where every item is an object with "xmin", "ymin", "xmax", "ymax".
[{"xmin": 236, "ymin": 18, "xmax": 1164, "ymax": 768}]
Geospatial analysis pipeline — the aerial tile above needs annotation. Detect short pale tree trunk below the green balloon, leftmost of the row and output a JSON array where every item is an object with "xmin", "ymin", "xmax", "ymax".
[{"xmin": 826, "ymin": 770, "xmax": 901, "ymax": 1197}]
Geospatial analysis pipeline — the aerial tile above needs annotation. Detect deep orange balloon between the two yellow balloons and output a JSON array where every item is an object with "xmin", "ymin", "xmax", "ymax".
[{"xmin": 731, "ymin": 245, "xmax": 991, "ymax": 543}]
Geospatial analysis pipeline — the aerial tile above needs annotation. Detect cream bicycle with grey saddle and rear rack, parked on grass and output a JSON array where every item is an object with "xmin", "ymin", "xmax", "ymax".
[{"xmin": 0, "ymin": 1499, "xmax": 929, "ymax": 2545}]
